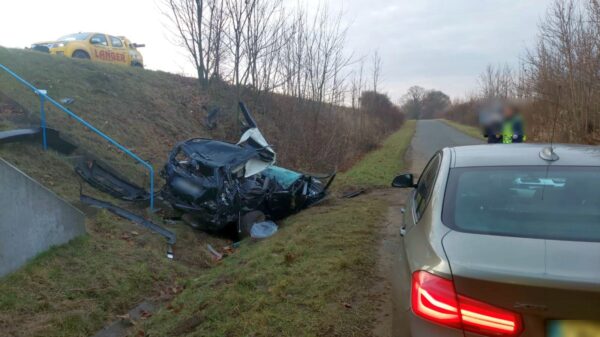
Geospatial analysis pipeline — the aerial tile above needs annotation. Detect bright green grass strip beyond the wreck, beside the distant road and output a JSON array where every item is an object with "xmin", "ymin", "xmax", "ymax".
[{"xmin": 335, "ymin": 120, "xmax": 416, "ymax": 189}]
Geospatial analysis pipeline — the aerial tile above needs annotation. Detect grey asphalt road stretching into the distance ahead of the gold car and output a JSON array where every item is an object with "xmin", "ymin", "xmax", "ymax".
[{"xmin": 409, "ymin": 120, "xmax": 482, "ymax": 175}]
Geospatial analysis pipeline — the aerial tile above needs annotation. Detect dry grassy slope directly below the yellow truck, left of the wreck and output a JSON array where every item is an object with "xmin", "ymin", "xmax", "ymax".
[{"xmin": 0, "ymin": 47, "xmax": 216, "ymax": 183}]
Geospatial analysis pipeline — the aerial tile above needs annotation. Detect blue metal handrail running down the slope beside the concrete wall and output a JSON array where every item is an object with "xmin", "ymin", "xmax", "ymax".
[{"xmin": 0, "ymin": 64, "xmax": 154, "ymax": 210}]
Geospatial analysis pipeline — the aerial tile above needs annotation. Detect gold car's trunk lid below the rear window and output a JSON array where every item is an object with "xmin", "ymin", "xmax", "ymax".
[{"xmin": 443, "ymin": 231, "xmax": 600, "ymax": 320}]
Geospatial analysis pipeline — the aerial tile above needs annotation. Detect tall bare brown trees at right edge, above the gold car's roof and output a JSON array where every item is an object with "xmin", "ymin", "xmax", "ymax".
[{"xmin": 524, "ymin": 0, "xmax": 600, "ymax": 142}]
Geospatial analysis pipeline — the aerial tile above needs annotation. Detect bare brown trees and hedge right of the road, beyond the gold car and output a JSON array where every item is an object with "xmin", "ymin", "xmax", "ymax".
[{"xmin": 440, "ymin": 0, "xmax": 600, "ymax": 143}]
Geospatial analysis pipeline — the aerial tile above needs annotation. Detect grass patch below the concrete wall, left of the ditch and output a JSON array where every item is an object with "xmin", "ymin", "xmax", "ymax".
[{"xmin": 0, "ymin": 181, "xmax": 230, "ymax": 337}]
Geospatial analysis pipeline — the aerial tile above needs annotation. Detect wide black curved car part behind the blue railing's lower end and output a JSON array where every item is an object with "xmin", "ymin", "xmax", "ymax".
[{"xmin": 75, "ymin": 159, "xmax": 150, "ymax": 201}]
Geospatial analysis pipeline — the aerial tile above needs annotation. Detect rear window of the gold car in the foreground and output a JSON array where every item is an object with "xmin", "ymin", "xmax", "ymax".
[{"xmin": 443, "ymin": 166, "xmax": 600, "ymax": 241}]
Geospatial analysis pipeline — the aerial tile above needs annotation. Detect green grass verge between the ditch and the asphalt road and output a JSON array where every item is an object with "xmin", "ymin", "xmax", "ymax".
[{"xmin": 136, "ymin": 123, "xmax": 414, "ymax": 337}]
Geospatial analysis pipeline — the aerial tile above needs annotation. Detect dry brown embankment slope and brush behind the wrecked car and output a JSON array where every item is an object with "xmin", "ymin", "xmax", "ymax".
[{"xmin": 0, "ymin": 47, "xmax": 401, "ymax": 175}]
